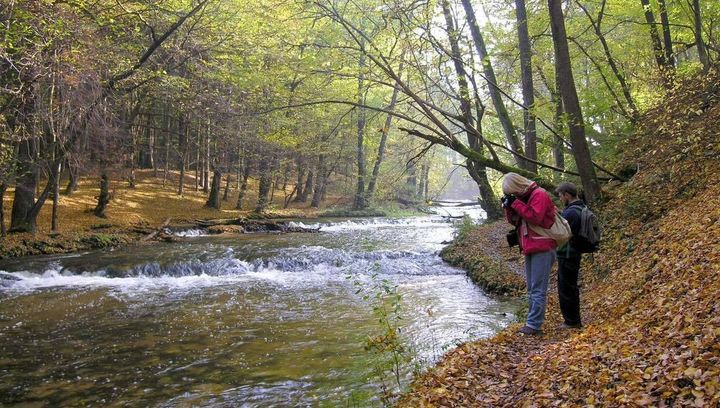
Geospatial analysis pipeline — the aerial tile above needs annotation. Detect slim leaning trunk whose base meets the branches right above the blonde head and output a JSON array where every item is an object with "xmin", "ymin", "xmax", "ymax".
[{"xmin": 462, "ymin": 0, "xmax": 527, "ymax": 170}]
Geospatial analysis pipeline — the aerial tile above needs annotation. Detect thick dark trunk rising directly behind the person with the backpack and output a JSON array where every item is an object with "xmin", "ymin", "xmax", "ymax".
[{"xmin": 548, "ymin": 0, "xmax": 601, "ymax": 204}]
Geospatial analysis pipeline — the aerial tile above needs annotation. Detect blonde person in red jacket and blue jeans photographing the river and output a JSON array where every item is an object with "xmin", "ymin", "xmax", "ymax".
[{"xmin": 501, "ymin": 173, "xmax": 557, "ymax": 334}]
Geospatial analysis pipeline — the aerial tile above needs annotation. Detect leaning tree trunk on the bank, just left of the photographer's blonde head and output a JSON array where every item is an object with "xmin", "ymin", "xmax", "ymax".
[{"xmin": 442, "ymin": 0, "xmax": 502, "ymax": 220}]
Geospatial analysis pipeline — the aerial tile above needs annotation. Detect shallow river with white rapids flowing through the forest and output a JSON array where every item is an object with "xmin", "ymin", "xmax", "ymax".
[{"xmin": 0, "ymin": 207, "xmax": 515, "ymax": 407}]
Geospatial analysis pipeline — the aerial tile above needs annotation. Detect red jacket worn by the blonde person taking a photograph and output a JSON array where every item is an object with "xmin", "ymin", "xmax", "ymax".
[{"xmin": 505, "ymin": 186, "xmax": 557, "ymax": 255}]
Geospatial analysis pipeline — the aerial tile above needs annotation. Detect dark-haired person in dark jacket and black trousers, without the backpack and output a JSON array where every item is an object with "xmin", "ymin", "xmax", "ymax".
[{"xmin": 555, "ymin": 182, "xmax": 585, "ymax": 329}]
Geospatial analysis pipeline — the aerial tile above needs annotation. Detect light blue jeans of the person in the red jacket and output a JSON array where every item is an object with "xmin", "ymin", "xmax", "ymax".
[{"xmin": 525, "ymin": 251, "xmax": 556, "ymax": 330}]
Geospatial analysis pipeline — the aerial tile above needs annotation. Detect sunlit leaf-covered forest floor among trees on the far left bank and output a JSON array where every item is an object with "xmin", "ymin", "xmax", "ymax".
[{"xmin": 0, "ymin": 170, "xmax": 412, "ymax": 259}]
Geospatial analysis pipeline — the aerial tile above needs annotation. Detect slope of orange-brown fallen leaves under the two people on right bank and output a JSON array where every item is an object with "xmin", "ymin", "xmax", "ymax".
[{"xmin": 398, "ymin": 71, "xmax": 720, "ymax": 407}]
